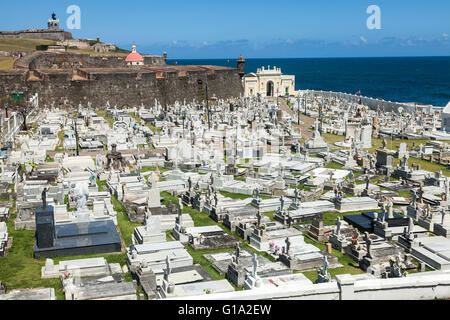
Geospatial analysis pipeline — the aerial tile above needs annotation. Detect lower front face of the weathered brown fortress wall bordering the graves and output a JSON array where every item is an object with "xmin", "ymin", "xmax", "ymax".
[{"xmin": 0, "ymin": 69, "xmax": 243, "ymax": 107}]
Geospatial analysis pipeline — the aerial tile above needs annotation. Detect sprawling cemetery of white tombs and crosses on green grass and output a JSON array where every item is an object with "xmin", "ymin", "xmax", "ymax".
[{"xmin": 0, "ymin": 92, "xmax": 450, "ymax": 300}]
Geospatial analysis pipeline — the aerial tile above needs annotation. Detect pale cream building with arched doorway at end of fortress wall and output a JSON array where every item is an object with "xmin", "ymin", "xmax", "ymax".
[{"xmin": 244, "ymin": 66, "xmax": 295, "ymax": 97}]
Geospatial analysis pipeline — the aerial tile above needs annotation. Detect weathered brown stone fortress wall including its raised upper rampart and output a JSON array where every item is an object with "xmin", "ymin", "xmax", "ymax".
[{"xmin": 0, "ymin": 52, "xmax": 243, "ymax": 107}]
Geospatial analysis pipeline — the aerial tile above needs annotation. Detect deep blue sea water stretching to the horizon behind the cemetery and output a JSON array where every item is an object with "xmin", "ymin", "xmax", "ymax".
[{"xmin": 168, "ymin": 57, "xmax": 450, "ymax": 106}]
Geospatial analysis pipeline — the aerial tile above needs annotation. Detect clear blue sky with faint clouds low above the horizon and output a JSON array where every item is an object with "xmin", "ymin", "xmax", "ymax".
[{"xmin": 0, "ymin": 0, "xmax": 450, "ymax": 59}]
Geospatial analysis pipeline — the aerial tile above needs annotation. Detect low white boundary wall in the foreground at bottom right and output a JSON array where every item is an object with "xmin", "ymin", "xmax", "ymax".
[{"xmin": 169, "ymin": 272, "xmax": 450, "ymax": 300}]
